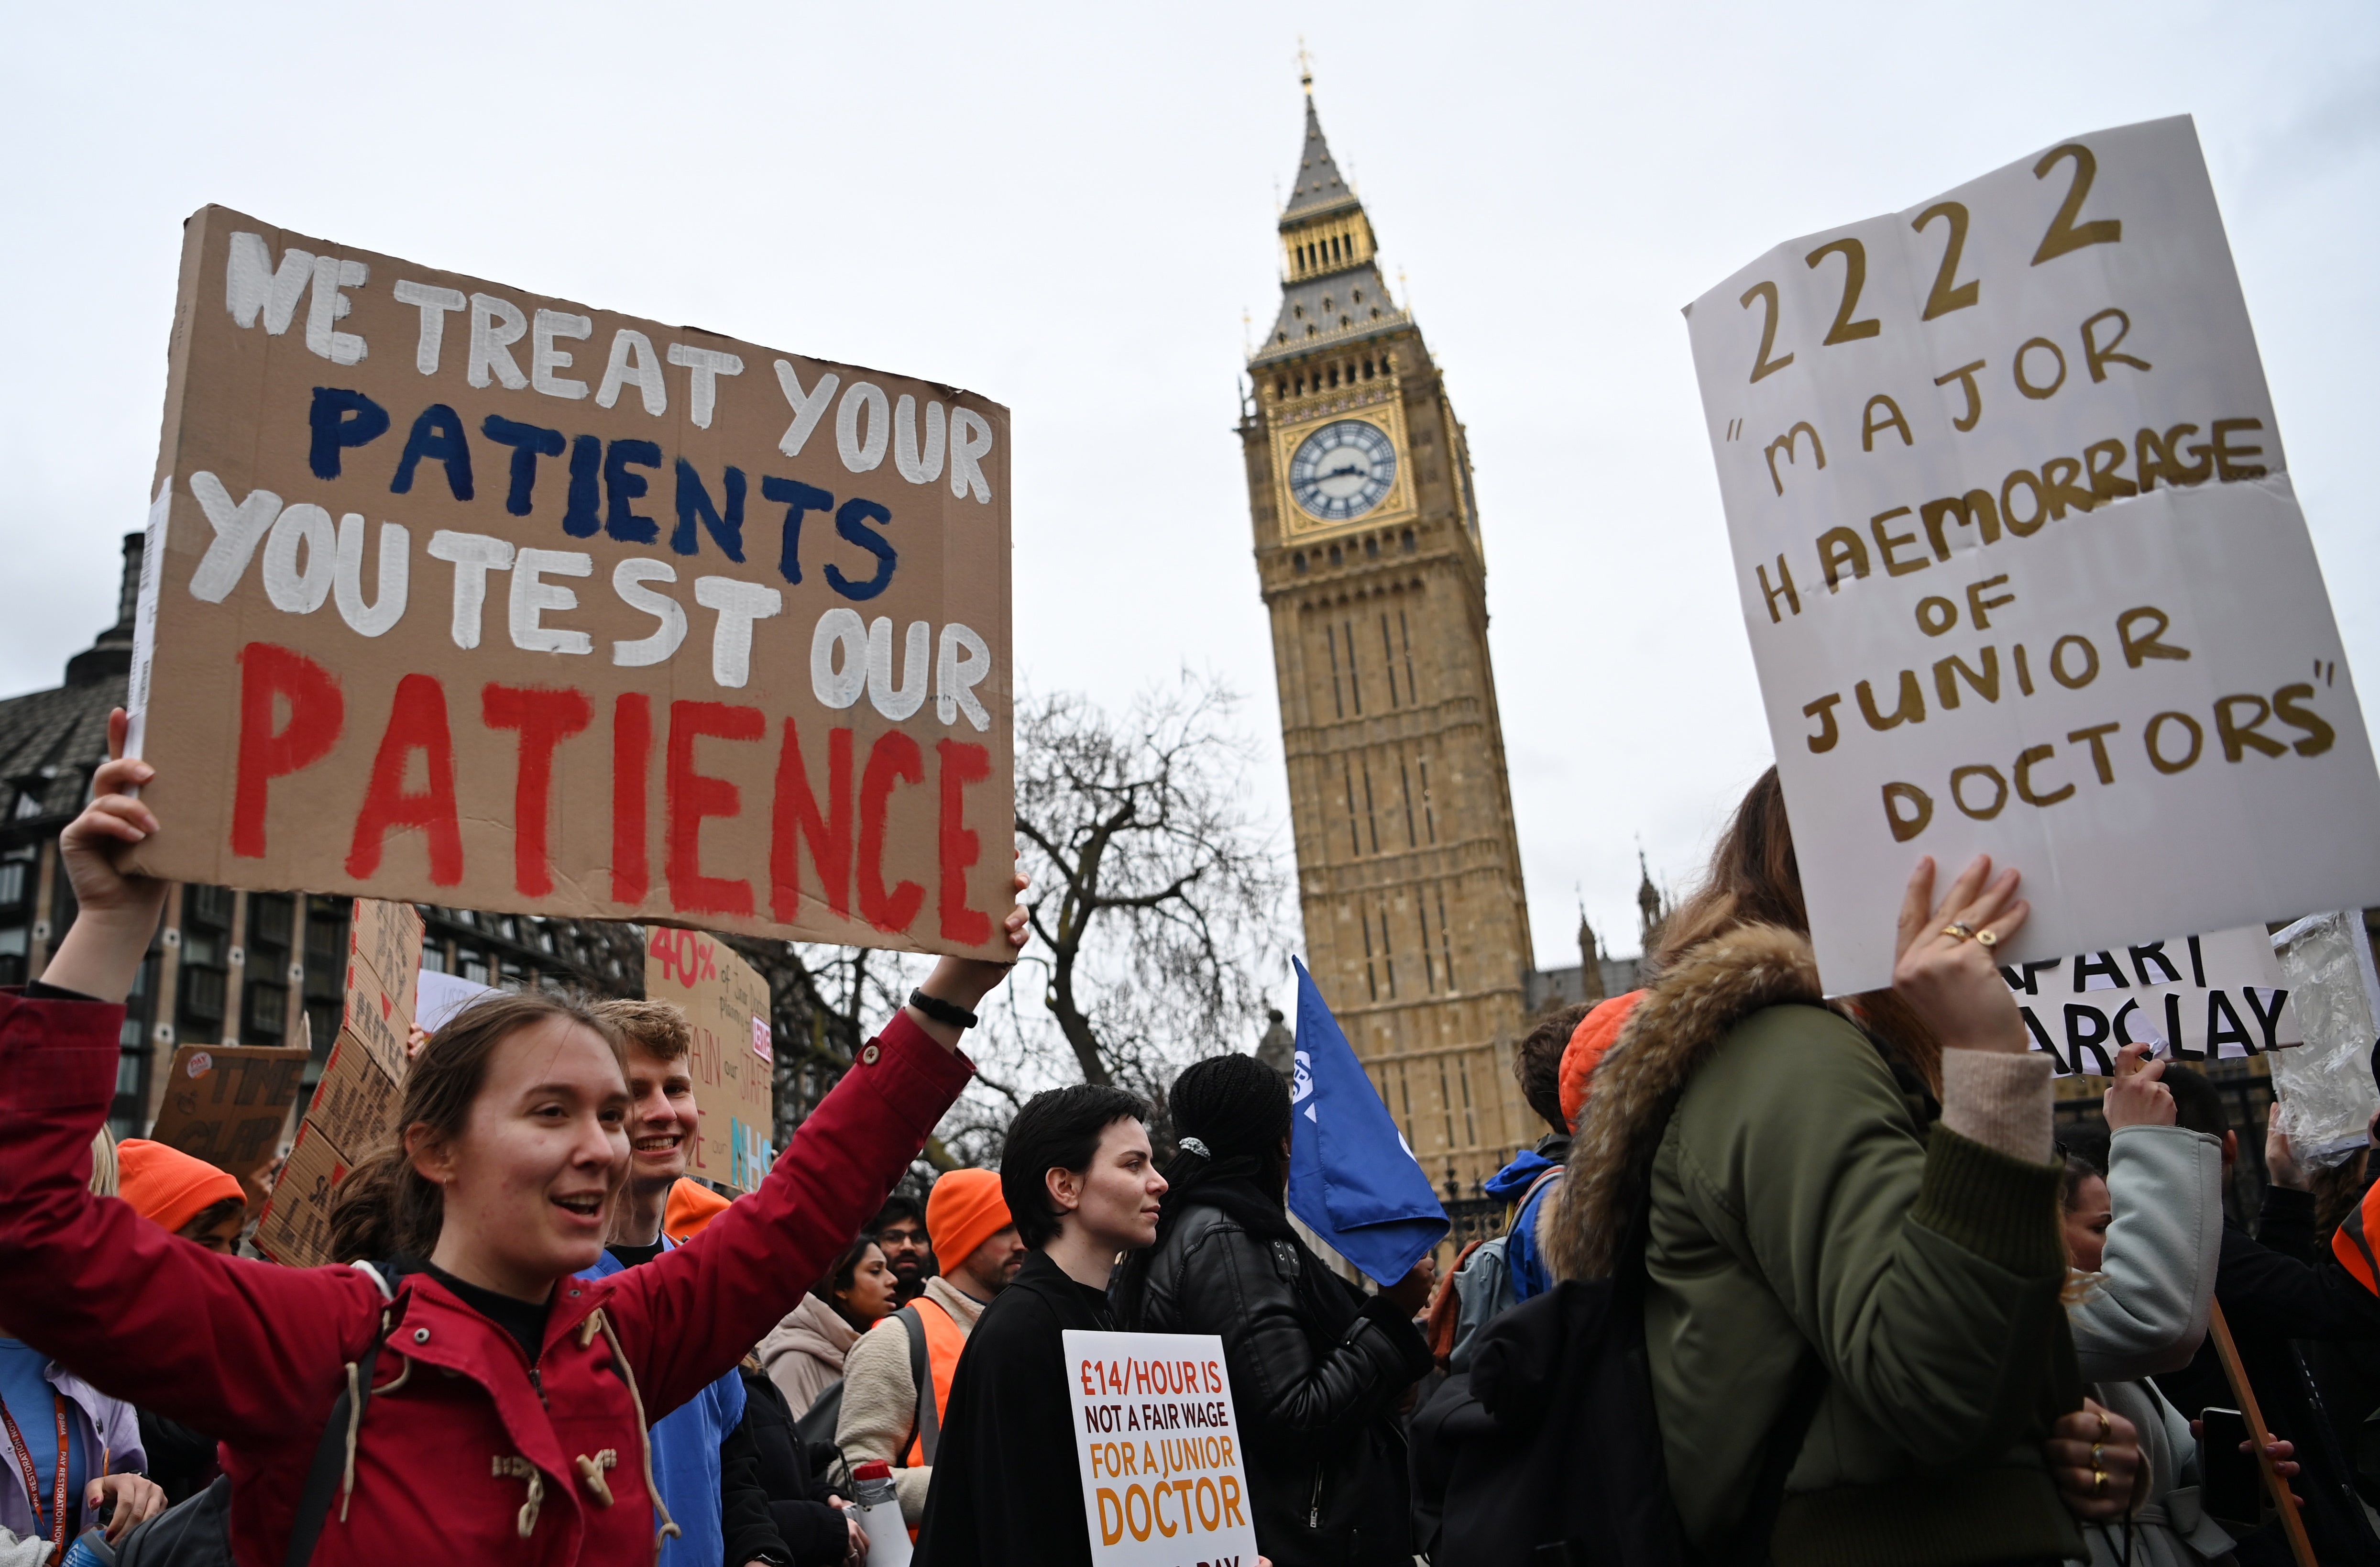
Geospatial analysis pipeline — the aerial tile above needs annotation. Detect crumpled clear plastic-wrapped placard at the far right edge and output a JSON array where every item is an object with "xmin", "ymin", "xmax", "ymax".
[{"xmin": 2273, "ymin": 910, "xmax": 2380, "ymax": 1165}]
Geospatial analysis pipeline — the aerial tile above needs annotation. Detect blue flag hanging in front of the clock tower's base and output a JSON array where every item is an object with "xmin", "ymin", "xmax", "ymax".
[{"xmin": 1290, "ymin": 957, "xmax": 1447, "ymax": 1284}]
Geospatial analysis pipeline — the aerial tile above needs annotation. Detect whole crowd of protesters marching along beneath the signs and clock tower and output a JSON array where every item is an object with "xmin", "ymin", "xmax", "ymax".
[{"xmin": 0, "ymin": 715, "xmax": 2380, "ymax": 1567}]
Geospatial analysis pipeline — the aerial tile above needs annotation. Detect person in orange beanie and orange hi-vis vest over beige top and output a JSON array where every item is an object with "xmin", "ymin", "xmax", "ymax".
[{"xmin": 835, "ymin": 1170, "xmax": 1026, "ymax": 1529}]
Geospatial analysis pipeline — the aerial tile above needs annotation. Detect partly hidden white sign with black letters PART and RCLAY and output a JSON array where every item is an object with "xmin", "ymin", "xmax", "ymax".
[{"xmin": 1999, "ymin": 927, "xmax": 2306, "ymax": 1076}]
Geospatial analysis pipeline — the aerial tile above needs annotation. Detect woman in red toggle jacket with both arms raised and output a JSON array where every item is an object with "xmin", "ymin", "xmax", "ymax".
[{"xmin": 0, "ymin": 712, "xmax": 1023, "ymax": 1567}]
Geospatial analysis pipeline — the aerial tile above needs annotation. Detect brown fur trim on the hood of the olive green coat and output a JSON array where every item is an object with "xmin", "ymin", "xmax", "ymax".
[{"xmin": 1537, "ymin": 924, "xmax": 1825, "ymax": 1279}]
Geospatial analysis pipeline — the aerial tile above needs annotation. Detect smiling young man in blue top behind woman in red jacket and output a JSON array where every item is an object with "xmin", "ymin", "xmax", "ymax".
[{"xmin": 583, "ymin": 1000, "xmax": 792, "ymax": 1567}]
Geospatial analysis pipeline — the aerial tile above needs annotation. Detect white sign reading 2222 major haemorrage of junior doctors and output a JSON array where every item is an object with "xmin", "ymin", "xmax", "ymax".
[{"xmin": 1688, "ymin": 119, "xmax": 2380, "ymax": 993}]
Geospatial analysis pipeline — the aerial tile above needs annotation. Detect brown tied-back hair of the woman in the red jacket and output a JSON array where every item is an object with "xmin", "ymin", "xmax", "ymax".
[{"xmin": 331, "ymin": 991, "xmax": 626, "ymax": 1262}]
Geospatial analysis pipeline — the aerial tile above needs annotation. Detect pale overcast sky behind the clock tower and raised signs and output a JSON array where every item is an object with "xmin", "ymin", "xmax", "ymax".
[{"xmin": 0, "ymin": 0, "xmax": 2380, "ymax": 967}]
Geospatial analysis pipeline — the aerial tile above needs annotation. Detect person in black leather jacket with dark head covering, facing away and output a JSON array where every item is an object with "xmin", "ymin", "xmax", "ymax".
[{"xmin": 1111, "ymin": 1055, "xmax": 1430, "ymax": 1567}]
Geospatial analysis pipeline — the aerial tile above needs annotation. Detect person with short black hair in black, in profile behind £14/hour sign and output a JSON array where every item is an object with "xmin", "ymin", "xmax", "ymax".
[{"xmin": 916, "ymin": 1083, "xmax": 1166, "ymax": 1567}]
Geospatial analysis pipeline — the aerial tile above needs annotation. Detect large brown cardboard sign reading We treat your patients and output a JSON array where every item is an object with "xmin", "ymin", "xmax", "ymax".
[{"xmin": 131, "ymin": 207, "xmax": 1014, "ymax": 955}]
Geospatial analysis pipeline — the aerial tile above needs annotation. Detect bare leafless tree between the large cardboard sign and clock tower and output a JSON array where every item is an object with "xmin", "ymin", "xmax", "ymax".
[{"xmin": 1016, "ymin": 674, "xmax": 1288, "ymax": 1093}]
